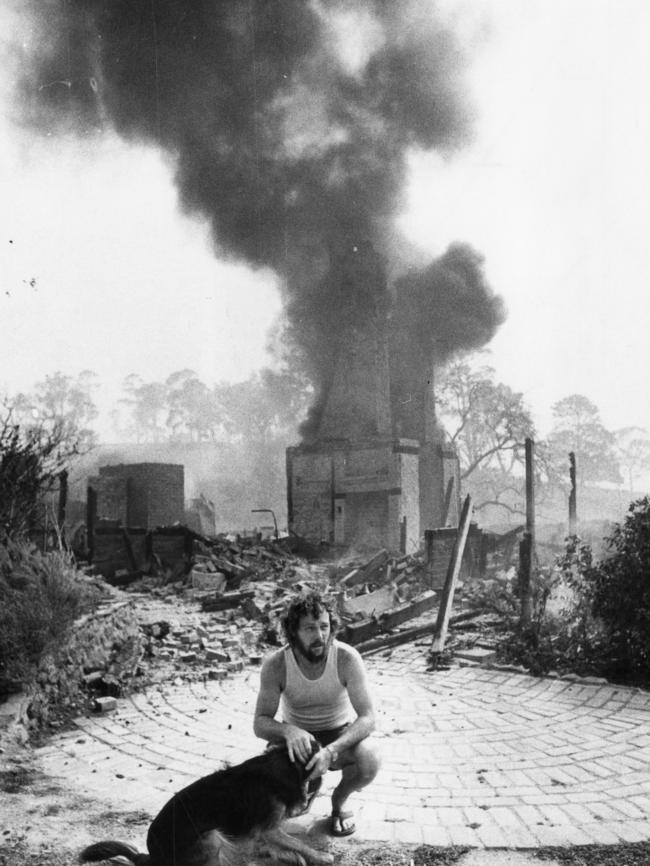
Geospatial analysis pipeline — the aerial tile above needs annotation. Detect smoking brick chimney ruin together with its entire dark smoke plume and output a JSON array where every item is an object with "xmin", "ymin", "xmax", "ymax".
[{"xmin": 17, "ymin": 0, "xmax": 503, "ymax": 550}]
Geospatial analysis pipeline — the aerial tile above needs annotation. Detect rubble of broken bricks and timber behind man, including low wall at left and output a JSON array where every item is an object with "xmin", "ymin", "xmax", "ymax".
[{"xmin": 1, "ymin": 533, "xmax": 511, "ymax": 728}]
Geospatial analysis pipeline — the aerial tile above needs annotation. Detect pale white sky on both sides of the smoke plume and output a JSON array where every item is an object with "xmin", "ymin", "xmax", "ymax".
[{"xmin": 0, "ymin": 0, "xmax": 650, "ymax": 434}]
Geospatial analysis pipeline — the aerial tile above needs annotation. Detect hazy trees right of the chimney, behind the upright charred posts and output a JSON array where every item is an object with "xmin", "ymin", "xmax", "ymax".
[{"xmin": 436, "ymin": 359, "xmax": 650, "ymax": 515}]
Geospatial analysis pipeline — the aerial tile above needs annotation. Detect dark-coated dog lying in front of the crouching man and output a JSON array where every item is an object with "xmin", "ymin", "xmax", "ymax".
[{"xmin": 79, "ymin": 745, "xmax": 333, "ymax": 866}]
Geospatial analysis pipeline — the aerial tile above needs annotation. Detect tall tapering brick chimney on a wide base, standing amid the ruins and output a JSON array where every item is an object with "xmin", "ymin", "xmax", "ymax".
[{"xmin": 287, "ymin": 244, "xmax": 458, "ymax": 553}]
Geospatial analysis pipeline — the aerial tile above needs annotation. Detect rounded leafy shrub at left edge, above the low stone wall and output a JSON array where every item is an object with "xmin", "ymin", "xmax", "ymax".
[{"xmin": 0, "ymin": 540, "xmax": 98, "ymax": 691}]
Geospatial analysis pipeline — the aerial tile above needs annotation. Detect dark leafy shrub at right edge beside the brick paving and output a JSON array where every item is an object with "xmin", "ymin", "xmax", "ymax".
[{"xmin": 492, "ymin": 497, "xmax": 650, "ymax": 685}]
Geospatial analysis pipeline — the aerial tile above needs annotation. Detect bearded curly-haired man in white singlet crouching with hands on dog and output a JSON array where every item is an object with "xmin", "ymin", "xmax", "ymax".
[{"xmin": 254, "ymin": 592, "xmax": 379, "ymax": 836}]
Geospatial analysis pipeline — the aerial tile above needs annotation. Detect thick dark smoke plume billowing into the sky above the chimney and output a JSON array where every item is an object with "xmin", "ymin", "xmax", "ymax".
[{"xmin": 13, "ymin": 0, "xmax": 500, "ymax": 432}]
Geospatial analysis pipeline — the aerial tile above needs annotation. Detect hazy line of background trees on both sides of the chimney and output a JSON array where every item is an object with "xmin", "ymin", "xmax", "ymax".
[{"xmin": 5, "ymin": 355, "xmax": 650, "ymax": 518}]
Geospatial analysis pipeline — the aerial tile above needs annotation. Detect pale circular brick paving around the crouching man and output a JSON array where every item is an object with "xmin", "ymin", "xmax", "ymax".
[{"xmin": 34, "ymin": 645, "xmax": 650, "ymax": 848}]
